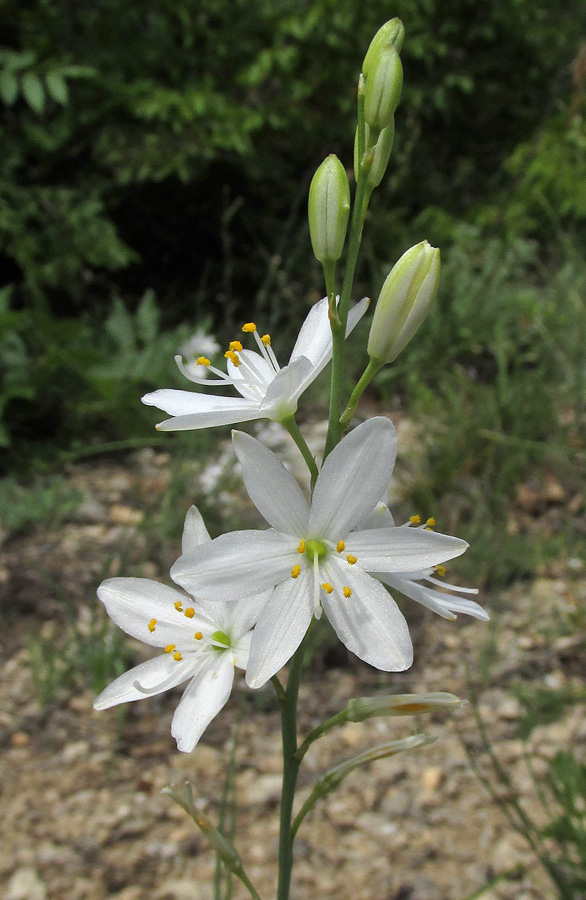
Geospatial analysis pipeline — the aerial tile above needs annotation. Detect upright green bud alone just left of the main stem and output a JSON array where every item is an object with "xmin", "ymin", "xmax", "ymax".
[{"xmin": 309, "ymin": 153, "xmax": 350, "ymax": 263}]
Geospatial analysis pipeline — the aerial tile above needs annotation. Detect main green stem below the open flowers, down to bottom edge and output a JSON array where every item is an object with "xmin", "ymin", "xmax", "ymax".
[{"xmin": 277, "ymin": 644, "xmax": 305, "ymax": 900}]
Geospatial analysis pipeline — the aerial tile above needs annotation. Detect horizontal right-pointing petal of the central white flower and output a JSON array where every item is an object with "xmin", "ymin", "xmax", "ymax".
[{"xmin": 346, "ymin": 528, "xmax": 468, "ymax": 572}]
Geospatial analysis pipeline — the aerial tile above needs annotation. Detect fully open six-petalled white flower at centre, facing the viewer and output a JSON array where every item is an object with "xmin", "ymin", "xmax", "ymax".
[{"xmin": 171, "ymin": 417, "xmax": 468, "ymax": 687}]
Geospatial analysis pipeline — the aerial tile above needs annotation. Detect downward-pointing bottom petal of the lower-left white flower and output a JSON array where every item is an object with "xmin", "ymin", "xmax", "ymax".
[{"xmin": 171, "ymin": 652, "xmax": 234, "ymax": 753}]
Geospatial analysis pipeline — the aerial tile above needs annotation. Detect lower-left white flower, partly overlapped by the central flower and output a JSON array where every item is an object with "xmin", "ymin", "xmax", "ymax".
[{"xmin": 94, "ymin": 506, "xmax": 268, "ymax": 753}]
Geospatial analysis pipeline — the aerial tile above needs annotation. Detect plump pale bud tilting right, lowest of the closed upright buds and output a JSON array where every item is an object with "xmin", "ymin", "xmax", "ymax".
[{"xmin": 368, "ymin": 241, "xmax": 440, "ymax": 363}]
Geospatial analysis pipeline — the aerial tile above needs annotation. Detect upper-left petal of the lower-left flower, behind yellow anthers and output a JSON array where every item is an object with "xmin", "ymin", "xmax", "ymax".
[{"xmin": 98, "ymin": 578, "xmax": 209, "ymax": 647}]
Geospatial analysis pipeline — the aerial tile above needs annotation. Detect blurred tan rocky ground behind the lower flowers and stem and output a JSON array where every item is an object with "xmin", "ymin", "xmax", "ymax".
[{"xmin": 0, "ymin": 426, "xmax": 586, "ymax": 900}]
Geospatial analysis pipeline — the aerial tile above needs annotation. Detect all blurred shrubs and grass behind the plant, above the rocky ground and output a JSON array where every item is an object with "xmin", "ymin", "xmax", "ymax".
[{"xmin": 0, "ymin": 0, "xmax": 586, "ymax": 583}]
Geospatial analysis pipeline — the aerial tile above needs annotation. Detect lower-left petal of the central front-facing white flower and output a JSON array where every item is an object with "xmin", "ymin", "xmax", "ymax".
[{"xmin": 246, "ymin": 567, "xmax": 313, "ymax": 688}]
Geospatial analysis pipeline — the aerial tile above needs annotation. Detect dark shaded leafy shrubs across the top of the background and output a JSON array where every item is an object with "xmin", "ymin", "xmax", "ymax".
[{"xmin": 0, "ymin": 0, "xmax": 586, "ymax": 324}]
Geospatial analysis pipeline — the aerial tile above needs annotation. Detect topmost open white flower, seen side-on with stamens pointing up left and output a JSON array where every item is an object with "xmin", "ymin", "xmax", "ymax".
[{"xmin": 142, "ymin": 297, "xmax": 369, "ymax": 431}]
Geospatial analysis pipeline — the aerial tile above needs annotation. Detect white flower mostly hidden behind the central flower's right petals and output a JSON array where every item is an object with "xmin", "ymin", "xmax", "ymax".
[{"xmin": 358, "ymin": 503, "xmax": 490, "ymax": 622}]
